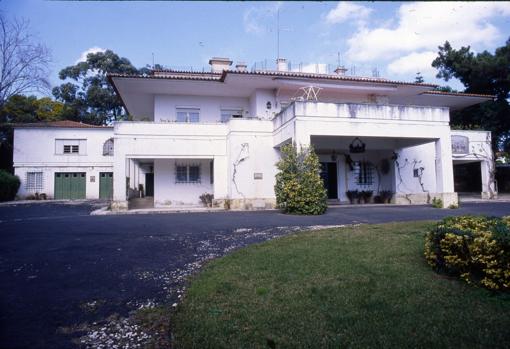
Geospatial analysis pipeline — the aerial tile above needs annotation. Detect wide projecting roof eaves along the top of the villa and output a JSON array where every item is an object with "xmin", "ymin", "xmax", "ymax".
[{"xmin": 108, "ymin": 72, "xmax": 494, "ymax": 117}]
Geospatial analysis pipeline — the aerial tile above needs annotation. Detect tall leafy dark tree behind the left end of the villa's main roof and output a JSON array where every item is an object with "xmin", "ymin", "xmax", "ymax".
[{"xmin": 53, "ymin": 50, "xmax": 139, "ymax": 125}]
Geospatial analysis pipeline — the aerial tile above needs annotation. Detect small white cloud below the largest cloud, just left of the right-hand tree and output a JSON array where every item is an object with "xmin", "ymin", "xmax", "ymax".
[{"xmin": 388, "ymin": 51, "xmax": 437, "ymax": 79}]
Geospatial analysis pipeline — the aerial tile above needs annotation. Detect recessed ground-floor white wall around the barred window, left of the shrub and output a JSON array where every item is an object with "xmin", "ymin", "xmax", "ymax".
[{"xmin": 154, "ymin": 159, "xmax": 213, "ymax": 207}]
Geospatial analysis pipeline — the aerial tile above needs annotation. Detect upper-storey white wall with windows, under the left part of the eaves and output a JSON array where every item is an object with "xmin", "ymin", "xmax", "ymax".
[{"xmin": 154, "ymin": 95, "xmax": 249, "ymax": 122}]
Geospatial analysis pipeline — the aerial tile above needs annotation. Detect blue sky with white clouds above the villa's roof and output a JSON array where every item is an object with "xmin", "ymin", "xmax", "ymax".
[{"xmin": 0, "ymin": 0, "xmax": 510, "ymax": 90}]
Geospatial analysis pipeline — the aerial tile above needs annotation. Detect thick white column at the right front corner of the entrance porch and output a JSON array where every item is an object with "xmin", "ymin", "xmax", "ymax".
[{"xmin": 435, "ymin": 134, "xmax": 458, "ymax": 207}]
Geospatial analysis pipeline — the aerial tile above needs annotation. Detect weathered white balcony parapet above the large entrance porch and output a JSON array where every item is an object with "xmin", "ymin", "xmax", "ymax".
[{"xmin": 273, "ymin": 101, "xmax": 450, "ymax": 130}]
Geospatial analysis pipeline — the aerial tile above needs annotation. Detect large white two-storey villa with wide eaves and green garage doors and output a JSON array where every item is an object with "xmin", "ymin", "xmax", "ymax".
[{"xmin": 14, "ymin": 58, "xmax": 495, "ymax": 209}]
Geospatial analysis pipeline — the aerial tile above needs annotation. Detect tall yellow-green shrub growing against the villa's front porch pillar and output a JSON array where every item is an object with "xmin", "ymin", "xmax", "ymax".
[{"xmin": 275, "ymin": 144, "xmax": 327, "ymax": 215}]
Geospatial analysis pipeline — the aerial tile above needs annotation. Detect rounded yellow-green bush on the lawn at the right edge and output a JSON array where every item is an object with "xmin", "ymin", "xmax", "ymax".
[{"xmin": 425, "ymin": 216, "xmax": 510, "ymax": 291}]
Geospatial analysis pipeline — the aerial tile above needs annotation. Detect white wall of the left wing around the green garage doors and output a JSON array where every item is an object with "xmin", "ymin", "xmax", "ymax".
[{"xmin": 13, "ymin": 128, "xmax": 113, "ymax": 199}]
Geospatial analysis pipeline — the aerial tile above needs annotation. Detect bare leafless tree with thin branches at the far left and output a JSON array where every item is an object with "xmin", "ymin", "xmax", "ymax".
[{"xmin": 0, "ymin": 13, "xmax": 51, "ymax": 107}]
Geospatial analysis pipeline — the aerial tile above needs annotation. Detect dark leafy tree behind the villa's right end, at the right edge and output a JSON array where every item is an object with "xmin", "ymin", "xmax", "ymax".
[{"xmin": 432, "ymin": 39, "xmax": 510, "ymax": 151}]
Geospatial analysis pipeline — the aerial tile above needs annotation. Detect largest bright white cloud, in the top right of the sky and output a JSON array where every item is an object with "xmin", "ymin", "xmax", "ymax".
[{"xmin": 347, "ymin": 2, "xmax": 510, "ymax": 62}]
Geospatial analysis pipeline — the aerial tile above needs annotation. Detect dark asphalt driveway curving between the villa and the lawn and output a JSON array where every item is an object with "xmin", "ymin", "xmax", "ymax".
[{"xmin": 0, "ymin": 202, "xmax": 510, "ymax": 348}]
